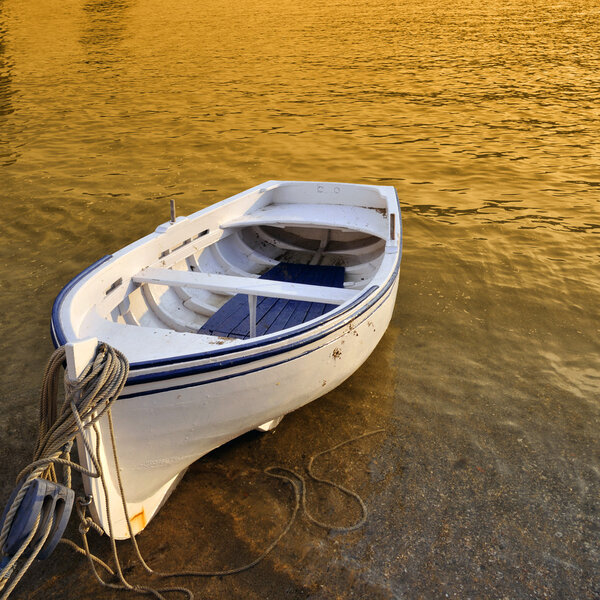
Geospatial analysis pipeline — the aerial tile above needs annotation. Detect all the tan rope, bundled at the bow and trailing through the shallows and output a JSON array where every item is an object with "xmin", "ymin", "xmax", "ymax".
[{"xmin": 0, "ymin": 343, "xmax": 384, "ymax": 600}]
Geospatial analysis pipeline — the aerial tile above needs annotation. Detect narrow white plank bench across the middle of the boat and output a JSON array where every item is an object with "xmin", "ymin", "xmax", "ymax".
[{"xmin": 132, "ymin": 267, "xmax": 356, "ymax": 304}]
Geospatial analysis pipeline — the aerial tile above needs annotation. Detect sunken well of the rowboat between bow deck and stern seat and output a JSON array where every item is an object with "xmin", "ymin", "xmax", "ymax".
[{"xmin": 110, "ymin": 223, "xmax": 385, "ymax": 339}]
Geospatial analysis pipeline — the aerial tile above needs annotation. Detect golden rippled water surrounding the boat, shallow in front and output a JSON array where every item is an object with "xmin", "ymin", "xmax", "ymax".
[{"xmin": 0, "ymin": 0, "xmax": 600, "ymax": 599}]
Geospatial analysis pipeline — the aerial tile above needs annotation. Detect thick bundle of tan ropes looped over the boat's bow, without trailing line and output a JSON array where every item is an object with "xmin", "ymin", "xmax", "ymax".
[{"xmin": 0, "ymin": 343, "xmax": 129, "ymax": 600}]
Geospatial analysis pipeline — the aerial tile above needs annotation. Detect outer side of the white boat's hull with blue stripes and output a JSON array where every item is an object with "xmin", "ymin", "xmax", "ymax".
[{"xmin": 80, "ymin": 274, "xmax": 399, "ymax": 539}]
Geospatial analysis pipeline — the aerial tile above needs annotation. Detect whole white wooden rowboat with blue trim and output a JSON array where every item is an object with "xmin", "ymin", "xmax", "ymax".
[{"xmin": 52, "ymin": 181, "xmax": 402, "ymax": 539}]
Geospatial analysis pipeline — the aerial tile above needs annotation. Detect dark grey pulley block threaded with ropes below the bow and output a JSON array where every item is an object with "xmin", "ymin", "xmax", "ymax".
[{"xmin": 0, "ymin": 477, "xmax": 75, "ymax": 560}]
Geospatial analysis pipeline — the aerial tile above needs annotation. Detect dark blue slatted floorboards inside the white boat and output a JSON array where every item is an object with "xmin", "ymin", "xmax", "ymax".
[{"xmin": 198, "ymin": 262, "xmax": 344, "ymax": 339}]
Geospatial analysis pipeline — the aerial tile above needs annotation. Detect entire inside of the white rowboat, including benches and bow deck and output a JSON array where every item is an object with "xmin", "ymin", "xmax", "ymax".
[{"xmin": 68, "ymin": 182, "xmax": 400, "ymax": 361}]
